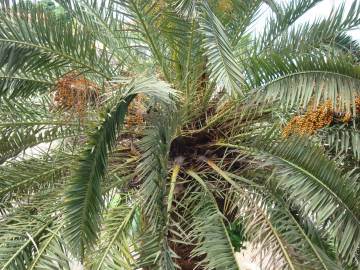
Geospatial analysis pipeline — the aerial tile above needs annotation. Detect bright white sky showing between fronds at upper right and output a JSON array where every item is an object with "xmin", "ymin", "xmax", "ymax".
[{"xmin": 255, "ymin": 0, "xmax": 360, "ymax": 41}]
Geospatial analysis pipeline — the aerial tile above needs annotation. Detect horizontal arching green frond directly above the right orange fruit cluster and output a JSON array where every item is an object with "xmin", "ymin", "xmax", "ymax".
[{"xmin": 248, "ymin": 54, "xmax": 360, "ymax": 111}]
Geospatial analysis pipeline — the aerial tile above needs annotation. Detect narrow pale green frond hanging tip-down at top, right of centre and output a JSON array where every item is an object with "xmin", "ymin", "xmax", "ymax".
[{"xmin": 200, "ymin": 1, "xmax": 244, "ymax": 94}]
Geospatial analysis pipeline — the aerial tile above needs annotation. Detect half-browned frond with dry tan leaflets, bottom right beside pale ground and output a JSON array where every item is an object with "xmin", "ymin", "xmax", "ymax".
[{"xmin": 238, "ymin": 190, "xmax": 342, "ymax": 270}]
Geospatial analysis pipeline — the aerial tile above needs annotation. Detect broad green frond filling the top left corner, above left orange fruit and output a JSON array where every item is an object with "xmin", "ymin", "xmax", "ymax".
[{"xmin": 0, "ymin": 0, "xmax": 112, "ymax": 84}]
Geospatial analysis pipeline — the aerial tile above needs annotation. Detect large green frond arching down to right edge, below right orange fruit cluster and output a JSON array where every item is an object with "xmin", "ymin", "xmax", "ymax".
[{"xmin": 252, "ymin": 139, "xmax": 360, "ymax": 264}]
